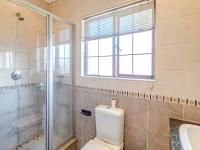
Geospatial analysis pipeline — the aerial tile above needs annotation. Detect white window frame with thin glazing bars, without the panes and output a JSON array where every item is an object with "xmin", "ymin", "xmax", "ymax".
[{"xmin": 81, "ymin": 0, "xmax": 156, "ymax": 80}]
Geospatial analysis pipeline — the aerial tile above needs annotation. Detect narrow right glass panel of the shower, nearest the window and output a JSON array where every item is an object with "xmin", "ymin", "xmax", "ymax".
[{"xmin": 53, "ymin": 19, "xmax": 73, "ymax": 149}]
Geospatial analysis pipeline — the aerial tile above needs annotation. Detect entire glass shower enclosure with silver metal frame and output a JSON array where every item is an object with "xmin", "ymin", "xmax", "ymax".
[{"xmin": 0, "ymin": 0, "xmax": 74, "ymax": 150}]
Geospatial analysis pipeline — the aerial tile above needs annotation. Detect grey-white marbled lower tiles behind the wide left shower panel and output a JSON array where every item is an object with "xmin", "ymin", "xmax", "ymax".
[{"xmin": 0, "ymin": 84, "xmax": 45, "ymax": 150}]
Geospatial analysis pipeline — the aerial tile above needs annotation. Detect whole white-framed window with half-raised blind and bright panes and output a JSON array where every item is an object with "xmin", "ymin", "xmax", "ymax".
[{"xmin": 82, "ymin": 1, "xmax": 154, "ymax": 79}]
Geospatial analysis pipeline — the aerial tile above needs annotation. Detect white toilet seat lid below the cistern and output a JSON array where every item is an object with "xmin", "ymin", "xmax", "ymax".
[{"xmin": 81, "ymin": 138, "xmax": 123, "ymax": 150}]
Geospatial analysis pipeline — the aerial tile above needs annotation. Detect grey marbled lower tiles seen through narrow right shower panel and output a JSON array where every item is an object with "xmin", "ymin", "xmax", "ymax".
[{"xmin": 54, "ymin": 83, "xmax": 73, "ymax": 143}]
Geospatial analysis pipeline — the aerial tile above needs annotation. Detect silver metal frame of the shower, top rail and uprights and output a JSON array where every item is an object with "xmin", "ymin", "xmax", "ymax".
[{"xmin": 8, "ymin": 0, "xmax": 75, "ymax": 150}]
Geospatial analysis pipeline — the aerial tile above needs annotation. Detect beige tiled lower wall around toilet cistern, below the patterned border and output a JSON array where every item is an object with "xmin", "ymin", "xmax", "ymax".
[{"xmin": 74, "ymin": 87, "xmax": 200, "ymax": 150}]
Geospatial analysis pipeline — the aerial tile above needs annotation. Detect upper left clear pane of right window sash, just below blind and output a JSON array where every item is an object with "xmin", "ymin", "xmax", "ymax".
[{"xmin": 119, "ymin": 34, "xmax": 133, "ymax": 55}]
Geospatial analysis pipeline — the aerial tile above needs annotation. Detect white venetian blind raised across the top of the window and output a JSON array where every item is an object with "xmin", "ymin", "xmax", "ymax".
[{"xmin": 83, "ymin": 1, "xmax": 154, "ymax": 41}]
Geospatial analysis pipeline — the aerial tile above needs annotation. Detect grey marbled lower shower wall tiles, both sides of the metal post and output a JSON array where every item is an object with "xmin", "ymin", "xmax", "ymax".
[{"xmin": 0, "ymin": 83, "xmax": 73, "ymax": 150}]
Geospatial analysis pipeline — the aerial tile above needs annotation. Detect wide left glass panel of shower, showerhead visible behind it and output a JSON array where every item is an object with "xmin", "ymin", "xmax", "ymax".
[{"xmin": 0, "ymin": 0, "xmax": 47, "ymax": 150}]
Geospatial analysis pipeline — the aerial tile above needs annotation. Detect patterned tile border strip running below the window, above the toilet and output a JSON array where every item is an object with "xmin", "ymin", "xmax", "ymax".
[{"xmin": 75, "ymin": 86, "xmax": 200, "ymax": 108}]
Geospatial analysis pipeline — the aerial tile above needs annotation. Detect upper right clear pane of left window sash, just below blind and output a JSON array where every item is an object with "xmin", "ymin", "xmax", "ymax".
[{"xmin": 99, "ymin": 37, "xmax": 113, "ymax": 56}]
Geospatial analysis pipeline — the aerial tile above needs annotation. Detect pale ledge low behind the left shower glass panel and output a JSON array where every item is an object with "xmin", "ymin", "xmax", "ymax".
[{"xmin": 12, "ymin": 113, "xmax": 42, "ymax": 130}]
